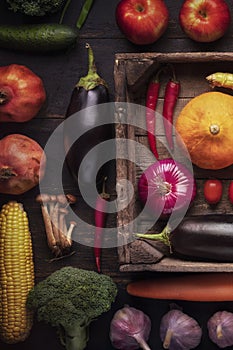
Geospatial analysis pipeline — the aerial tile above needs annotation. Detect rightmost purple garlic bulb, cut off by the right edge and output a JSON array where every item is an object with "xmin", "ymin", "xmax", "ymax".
[{"xmin": 207, "ymin": 311, "xmax": 233, "ymax": 348}]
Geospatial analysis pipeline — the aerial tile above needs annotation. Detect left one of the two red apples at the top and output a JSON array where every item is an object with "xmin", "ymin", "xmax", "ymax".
[{"xmin": 116, "ymin": 0, "xmax": 169, "ymax": 45}]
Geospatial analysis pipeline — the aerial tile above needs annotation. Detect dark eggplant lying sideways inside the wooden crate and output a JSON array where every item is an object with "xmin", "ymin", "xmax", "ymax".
[{"xmin": 137, "ymin": 214, "xmax": 233, "ymax": 262}]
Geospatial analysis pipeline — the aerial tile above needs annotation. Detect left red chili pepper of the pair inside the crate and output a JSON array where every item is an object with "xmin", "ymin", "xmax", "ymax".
[{"xmin": 146, "ymin": 69, "xmax": 162, "ymax": 159}]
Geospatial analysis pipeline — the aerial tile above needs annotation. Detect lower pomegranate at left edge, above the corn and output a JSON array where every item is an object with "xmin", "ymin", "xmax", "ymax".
[{"xmin": 0, "ymin": 134, "xmax": 46, "ymax": 195}]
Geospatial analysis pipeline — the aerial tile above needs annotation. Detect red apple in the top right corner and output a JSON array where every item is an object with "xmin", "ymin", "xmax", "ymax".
[{"xmin": 179, "ymin": 0, "xmax": 231, "ymax": 43}]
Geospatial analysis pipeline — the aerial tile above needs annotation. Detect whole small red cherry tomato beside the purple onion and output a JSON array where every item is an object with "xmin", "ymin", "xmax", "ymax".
[{"xmin": 204, "ymin": 179, "xmax": 222, "ymax": 204}]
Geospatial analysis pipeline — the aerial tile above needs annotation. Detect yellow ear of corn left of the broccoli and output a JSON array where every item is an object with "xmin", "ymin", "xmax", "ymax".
[{"xmin": 0, "ymin": 201, "xmax": 34, "ymax": 344}]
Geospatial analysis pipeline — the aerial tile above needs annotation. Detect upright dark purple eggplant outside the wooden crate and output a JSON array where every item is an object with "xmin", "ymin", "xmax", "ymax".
[{"xmin": 63, "ymin": 44, "xmax": 113, "ymax": 193}]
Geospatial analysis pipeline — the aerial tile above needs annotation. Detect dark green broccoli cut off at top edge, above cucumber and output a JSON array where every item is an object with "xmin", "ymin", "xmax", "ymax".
[{"xmin": 6, "ymin": 0, "xmax": 65, "ymax": 16}]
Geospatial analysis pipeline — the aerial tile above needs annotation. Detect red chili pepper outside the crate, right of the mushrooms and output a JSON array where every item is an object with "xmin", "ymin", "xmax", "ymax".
[{"xmin": 94, "ymin": 178, "xmax": 110, "ymax": 273}]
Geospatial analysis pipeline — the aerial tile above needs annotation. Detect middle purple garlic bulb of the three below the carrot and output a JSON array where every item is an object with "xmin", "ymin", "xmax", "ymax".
[{"xmin": 160, "ymin": 310, "xmax": 202, "ymax": 350}]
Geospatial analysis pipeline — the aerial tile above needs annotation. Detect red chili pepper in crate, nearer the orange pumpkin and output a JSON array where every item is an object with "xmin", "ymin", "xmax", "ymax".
[{"xmin": 163, "ymin": 67, "xmax": 180, "ymax": 150}]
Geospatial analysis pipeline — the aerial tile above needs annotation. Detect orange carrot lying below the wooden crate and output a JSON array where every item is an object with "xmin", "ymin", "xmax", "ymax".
[{"xmin": 127, "ymin": 272, "xmax": 233, "ymax": 302}]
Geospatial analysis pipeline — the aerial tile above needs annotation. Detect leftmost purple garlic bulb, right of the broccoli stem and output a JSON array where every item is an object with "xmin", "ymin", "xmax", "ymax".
[{"xmin": 110, "ymin": 305, "xmax": 151, "ymax": 350}]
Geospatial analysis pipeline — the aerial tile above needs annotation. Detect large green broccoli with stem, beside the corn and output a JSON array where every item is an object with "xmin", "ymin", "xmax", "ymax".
[{"xmin": 27, "ymin": 266, "xmax": 117, "ymax": 350}]
